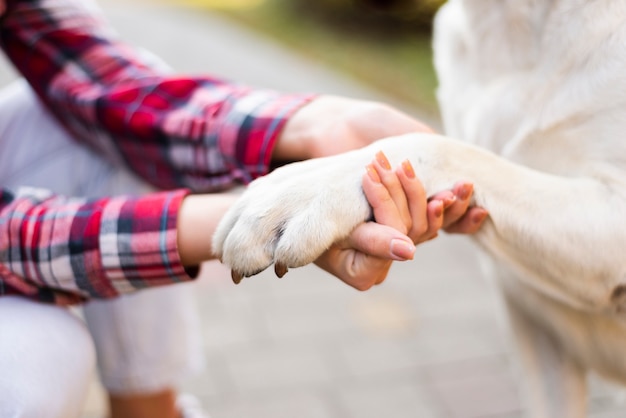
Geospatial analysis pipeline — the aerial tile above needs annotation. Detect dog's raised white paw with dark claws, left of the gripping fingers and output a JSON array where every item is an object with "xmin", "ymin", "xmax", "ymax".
[{"xmin": 213, "ymin": 151, "xmax": 370, "ymax": 283}]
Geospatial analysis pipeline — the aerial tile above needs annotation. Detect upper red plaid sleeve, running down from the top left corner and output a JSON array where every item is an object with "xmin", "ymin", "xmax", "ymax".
[{"xmin": 0, "ymin": 0, "xmax": 312, "ymax": 191}]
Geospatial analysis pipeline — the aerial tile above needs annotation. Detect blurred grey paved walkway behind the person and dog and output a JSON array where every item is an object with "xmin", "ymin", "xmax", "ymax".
[{"xmin": 0, "ymin": 0, "xmax": 626, "ymax": 418}]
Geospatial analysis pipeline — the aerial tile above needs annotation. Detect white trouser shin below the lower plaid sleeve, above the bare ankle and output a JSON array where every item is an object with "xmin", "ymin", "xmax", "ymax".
[{"xmin": 85, "ymin": 283, "xmax": 203, "ymax": 395}]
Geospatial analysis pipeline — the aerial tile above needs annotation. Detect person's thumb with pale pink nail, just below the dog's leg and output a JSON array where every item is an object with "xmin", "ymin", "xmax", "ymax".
[{"xmin": 348, "ymin": 222, "xmax": 415, "ymax": 261}]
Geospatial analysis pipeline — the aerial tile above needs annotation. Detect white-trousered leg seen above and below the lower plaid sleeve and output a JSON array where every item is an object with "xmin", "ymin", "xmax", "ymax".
[{"xmin": 0, "ymin": 81, "xmax": 202, "ymax": 394}]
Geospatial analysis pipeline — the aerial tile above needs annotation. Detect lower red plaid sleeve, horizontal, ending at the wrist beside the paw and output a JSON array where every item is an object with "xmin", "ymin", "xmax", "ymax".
[{"xmin": 0, "ymin": 188, "xmax": 191, "ymax": 304}]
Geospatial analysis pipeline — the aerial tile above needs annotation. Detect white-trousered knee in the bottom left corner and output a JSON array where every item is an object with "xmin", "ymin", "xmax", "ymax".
[{"xmin": 0, "ymin": 296, "xmax": 96, "ymax": 418}]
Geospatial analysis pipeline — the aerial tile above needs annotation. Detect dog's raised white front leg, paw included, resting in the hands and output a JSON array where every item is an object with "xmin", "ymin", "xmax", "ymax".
[{"xmin": 213, "ymin": 134, "xmax": 626, "ymax": 311}]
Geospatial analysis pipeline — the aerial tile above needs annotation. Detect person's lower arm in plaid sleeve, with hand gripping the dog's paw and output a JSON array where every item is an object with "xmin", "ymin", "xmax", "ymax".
[{"xmin": 0, "ymin": 173, "xmax": 472, "ymax": 305}]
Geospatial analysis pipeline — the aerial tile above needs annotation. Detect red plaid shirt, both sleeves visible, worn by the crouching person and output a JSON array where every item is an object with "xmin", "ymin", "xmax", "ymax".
[{"xmin": 0, "ymin": 0, "xmax": 311, "ymax": 304}]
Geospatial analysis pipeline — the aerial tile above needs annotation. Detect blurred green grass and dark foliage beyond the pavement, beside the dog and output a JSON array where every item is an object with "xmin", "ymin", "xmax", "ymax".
[{"xmin": 217, "ymin": 0, "xmax": 443, "ymax": 115}]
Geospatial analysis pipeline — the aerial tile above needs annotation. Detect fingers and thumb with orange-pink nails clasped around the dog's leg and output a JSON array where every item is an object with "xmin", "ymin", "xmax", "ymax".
[{"xmin": 316, "ymin": 153, "xmax": 486, "ymax": 290}]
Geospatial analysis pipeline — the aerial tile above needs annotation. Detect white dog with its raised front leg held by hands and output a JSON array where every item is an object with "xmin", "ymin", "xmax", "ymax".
[{"xmin": 214, "ymin": 0, "xmax": 626, "ymax": 418}]
